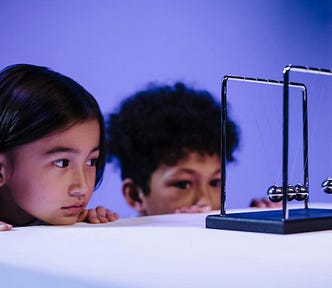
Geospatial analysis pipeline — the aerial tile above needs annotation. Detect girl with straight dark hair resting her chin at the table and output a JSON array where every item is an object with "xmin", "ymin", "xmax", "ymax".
[{"xmin": 0, "ymin": 64, "xmax": 118, "ymax": 230}]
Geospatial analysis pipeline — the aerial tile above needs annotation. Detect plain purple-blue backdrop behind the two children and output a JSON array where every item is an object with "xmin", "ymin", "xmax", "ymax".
[{"xmin": 0, "ymin": 0, "xmax": 332, "ymax": 217}]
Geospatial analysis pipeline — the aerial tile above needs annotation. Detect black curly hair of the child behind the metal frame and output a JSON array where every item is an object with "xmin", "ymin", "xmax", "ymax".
[{"xmin": 106, "ymin": 83, "xmax": 239, "ymax": 195}]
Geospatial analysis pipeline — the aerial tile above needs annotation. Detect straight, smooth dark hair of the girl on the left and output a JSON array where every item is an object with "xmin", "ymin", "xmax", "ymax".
[{"xmin": 0, "ymin": 64, "xmax": 106, "ymax": 186}]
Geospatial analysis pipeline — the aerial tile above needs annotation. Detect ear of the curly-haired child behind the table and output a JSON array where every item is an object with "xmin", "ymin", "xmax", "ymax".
[{"xmin": 122, "ymin": 178, "xmax": 146, "ymax": 214}]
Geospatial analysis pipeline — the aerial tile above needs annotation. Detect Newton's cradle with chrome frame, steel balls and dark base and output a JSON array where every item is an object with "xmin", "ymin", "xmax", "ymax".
[{"xmin": 206, "ymin": 65, "xmax": 332, "ymax": 234}]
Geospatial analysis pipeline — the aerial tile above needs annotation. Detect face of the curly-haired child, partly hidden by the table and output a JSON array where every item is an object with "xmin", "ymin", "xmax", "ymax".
[{"xmin": 132, "ymin": 152, "xmax": 220, "ymax": 215}]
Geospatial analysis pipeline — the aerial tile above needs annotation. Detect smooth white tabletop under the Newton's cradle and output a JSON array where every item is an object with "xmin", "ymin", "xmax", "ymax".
[{"xmin": 0, "ymin": 206, "xmax": 332, "ymax": 288}]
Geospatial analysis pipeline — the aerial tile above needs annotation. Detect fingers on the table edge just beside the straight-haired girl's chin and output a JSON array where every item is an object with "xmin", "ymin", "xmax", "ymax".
[{"xmin": 77, "ymin": 206, "xmax": 119, "ymax": 224}]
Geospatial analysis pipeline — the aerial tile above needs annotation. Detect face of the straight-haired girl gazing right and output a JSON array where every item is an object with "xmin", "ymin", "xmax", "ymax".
[{"xmin": 1, "ymin": 120, "xmax": 100, "ymax": 225}]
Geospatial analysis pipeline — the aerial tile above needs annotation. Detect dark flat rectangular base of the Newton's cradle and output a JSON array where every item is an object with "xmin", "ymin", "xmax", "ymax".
[{"xmin": 206, "ymin": 208, "xmax": 332, "ymax": 234}]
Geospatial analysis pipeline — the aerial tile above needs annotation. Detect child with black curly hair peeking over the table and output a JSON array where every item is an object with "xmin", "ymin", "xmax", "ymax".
[{"xmin": 107, "ymin": 83, "xmax": 239, "ymax": 216}]
